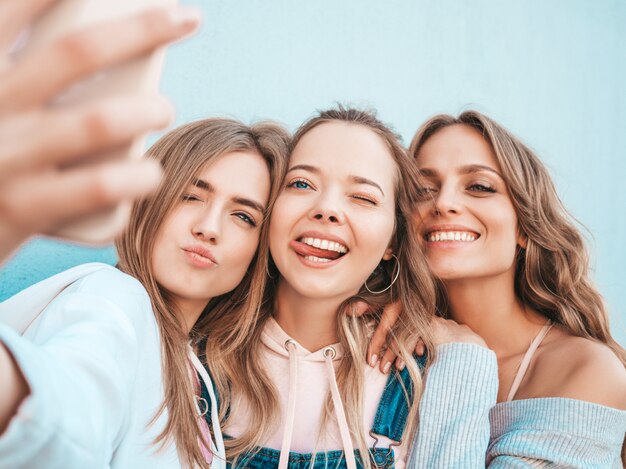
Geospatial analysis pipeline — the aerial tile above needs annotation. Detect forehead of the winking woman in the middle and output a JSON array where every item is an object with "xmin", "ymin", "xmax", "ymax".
[{"xmin": 289, "ymin": 122, "xmax": 397, "ymax": 188}]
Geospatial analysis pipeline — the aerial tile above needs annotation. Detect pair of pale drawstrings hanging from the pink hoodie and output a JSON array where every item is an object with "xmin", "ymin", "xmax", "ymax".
[{"xmin": 278, "ymin": 339, "xmax": 356, "ymax": 469}]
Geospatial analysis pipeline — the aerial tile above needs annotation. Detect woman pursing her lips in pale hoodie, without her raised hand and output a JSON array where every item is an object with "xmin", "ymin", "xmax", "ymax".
[{"xmin": 0, "ymin": 115, "xmax": 289, "ymax": 468}]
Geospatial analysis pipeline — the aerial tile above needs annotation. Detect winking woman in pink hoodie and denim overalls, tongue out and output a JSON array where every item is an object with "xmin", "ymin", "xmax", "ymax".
[{"xmin": 197, "ymin": 107, "xmax": 495, "ymax": 468}]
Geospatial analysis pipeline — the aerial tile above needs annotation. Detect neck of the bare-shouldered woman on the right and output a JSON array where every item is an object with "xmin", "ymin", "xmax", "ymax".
[{"xmin": 446, "ymin": 274, "xmax": 546, "ymax": 358}]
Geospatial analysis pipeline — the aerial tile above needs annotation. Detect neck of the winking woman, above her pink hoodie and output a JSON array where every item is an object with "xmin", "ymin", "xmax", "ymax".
[{"xmin": 274, "ymin": 280, "xmax": 344, "ymax": 352}]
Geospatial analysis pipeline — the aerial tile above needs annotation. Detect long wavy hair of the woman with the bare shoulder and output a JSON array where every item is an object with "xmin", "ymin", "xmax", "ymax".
[{"xmin": 409, "ymin": 111, "xmax": 626, "ymax": 463}]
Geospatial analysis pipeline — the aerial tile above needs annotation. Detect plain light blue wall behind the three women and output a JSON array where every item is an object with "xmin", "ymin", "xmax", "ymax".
[{"xmin": 0, "ymin": 0, "xmax": 626, "ymax": 345}]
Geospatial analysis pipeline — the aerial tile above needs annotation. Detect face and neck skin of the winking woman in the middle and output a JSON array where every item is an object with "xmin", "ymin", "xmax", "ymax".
[{"xmin": 270, "ymin": 122, "xmax": 396, "ymax": 351}]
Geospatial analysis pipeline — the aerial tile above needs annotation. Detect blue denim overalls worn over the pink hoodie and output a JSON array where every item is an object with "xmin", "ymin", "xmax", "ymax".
[{"xmin": 200, "ymin": 347, "xmax": 426, "ymax": 469}]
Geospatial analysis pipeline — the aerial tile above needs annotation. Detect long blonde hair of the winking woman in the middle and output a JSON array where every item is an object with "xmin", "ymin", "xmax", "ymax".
[{"xmin": 202, "ymin": 107, "xmax": 435, "ymax": 468}]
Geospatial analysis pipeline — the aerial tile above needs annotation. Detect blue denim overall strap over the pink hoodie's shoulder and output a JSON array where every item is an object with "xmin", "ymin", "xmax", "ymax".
[{"xmin": 370, "ymin": 355, "xmax": 426, "ymax": 444}]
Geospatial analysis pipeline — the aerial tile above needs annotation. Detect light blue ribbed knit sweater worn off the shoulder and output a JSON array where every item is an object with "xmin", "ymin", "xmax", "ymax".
[{"xmin": 407, "ymin": 344, "xmax": 626, "ymax": 469}]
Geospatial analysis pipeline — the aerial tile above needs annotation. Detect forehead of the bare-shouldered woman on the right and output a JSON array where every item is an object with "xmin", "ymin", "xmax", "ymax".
[{"xmin": 417, "ymin": 124, "xmax": 499, "ymax": 170}]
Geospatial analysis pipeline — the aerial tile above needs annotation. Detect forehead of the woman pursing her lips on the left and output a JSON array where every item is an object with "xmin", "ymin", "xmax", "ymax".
[{"xmin": 196, "ymin": 150, "xmax": 270, "ymax": 203}]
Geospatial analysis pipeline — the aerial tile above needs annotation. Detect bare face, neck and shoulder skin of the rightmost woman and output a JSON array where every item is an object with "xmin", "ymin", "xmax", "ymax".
[{"xmin": 417, "ymin": 125, "xmax": 626, "ymax": 409}]
